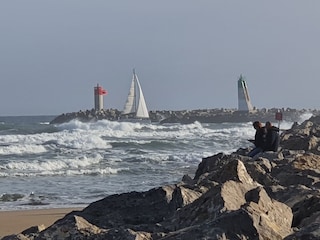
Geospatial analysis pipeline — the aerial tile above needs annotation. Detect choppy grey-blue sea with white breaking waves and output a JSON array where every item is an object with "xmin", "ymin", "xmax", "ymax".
[{"xmin": 0, "ymin": 114, "xmax": 311, "ymax": 211}]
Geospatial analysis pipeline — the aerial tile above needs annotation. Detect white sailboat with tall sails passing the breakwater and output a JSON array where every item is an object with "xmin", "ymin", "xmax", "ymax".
[{"xmin": 121, "ymin": 69, "xmax": 151, "ymax": 122}]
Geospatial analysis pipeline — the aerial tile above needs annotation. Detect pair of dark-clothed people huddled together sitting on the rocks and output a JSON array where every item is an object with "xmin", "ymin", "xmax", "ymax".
[{"xmin": 248, "ymin": 121, "xmax": 280, "ymax": 157}]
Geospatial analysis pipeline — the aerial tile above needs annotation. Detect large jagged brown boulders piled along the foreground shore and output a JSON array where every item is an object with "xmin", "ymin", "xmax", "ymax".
[{"xmin": 3, "ymin": 116, "xmax": 320, "ymax": 240}]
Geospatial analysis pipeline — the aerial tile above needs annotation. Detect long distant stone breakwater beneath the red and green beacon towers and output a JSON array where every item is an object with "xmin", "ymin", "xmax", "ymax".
[{"xmin": 50, "ymin": 108, "xmax": 320, "ymax": 124}]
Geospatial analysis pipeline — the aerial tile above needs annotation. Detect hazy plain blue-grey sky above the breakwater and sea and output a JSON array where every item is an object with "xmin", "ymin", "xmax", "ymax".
[{"xmin": 0, "ymin": 0, "xmax": 320, "ymax": 116}]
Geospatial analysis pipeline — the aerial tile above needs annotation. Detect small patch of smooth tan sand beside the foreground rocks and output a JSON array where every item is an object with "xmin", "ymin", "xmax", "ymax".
[{"xmin": 0, "ymin": 208, "xmax": 82, "ymax": 239}]
